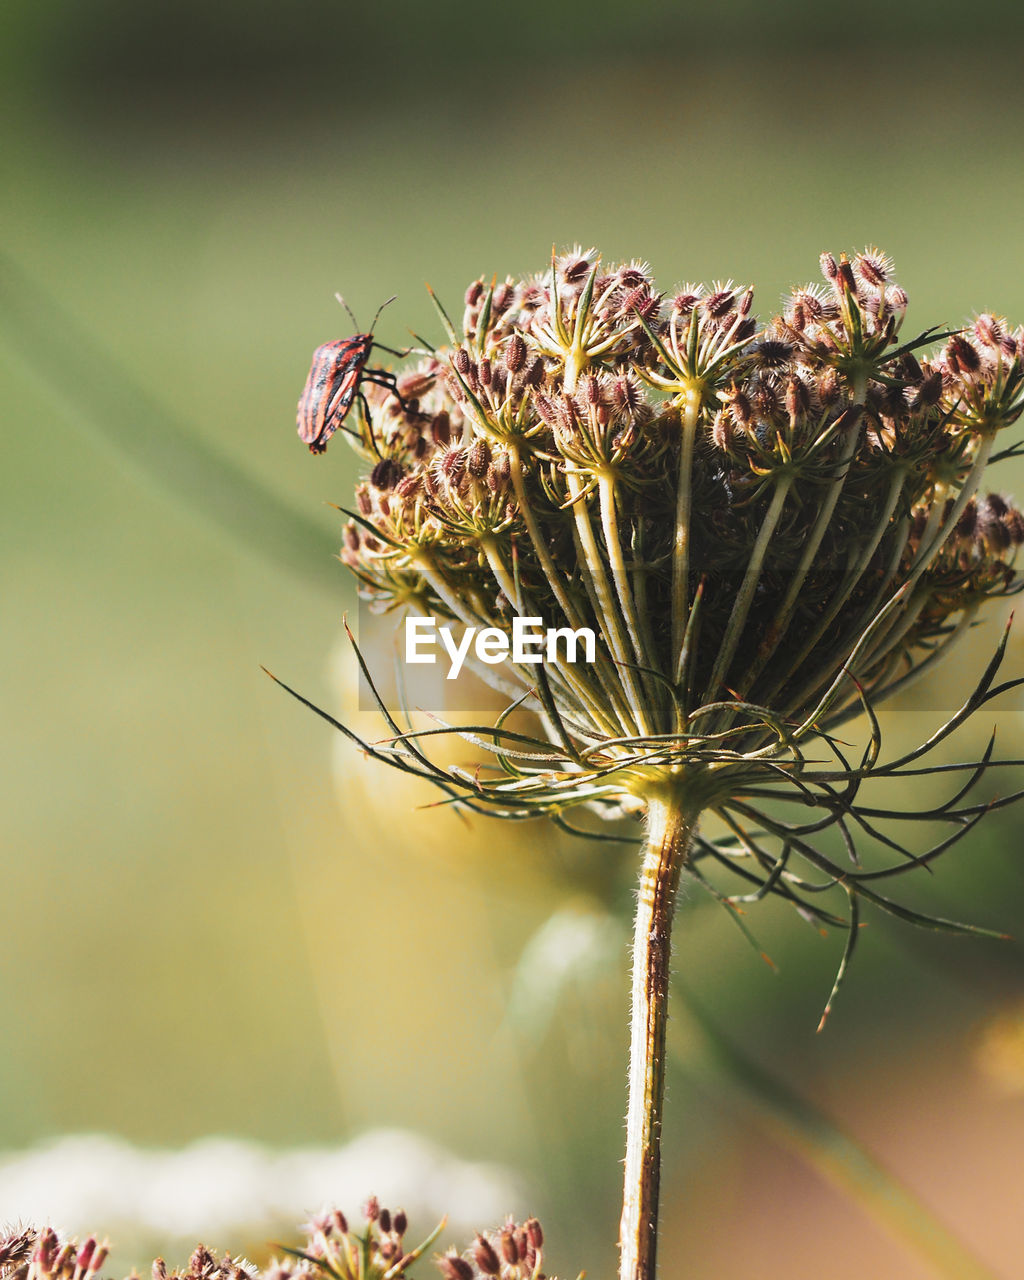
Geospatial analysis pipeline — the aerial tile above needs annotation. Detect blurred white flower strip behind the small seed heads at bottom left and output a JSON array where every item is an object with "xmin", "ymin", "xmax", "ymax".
[{"xmin": 0, "ymin": 1129, "xmax": 522, "ymax": 1252}]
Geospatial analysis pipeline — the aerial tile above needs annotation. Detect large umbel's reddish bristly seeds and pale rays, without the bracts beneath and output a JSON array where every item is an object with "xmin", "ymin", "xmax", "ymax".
[{"xmin": 343, "ymin": 251, "xmax": 1024, "ymax": 747}]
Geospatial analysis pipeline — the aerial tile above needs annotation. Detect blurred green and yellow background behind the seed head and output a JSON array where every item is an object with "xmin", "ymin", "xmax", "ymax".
[{"xmin": 0, "ymin": 0, "xmax": 1024, "ymax": 1280}]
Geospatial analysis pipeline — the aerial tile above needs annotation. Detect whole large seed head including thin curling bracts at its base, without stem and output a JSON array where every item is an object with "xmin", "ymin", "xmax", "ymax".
[{"xmin": 284, "ymin": 250, "xmax": 1024, "ymax": 1008}]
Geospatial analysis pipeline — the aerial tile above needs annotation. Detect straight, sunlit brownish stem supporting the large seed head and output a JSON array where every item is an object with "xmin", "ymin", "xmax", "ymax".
[{"xmin": 618, "ymin": 790, "xmax": 699, "ymax": 1280}]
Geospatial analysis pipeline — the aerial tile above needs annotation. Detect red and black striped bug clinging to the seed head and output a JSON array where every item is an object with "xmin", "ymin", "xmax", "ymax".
[{"xmin": 297, "ymin": 294, "xmax": 407, "ymax": 453}]
